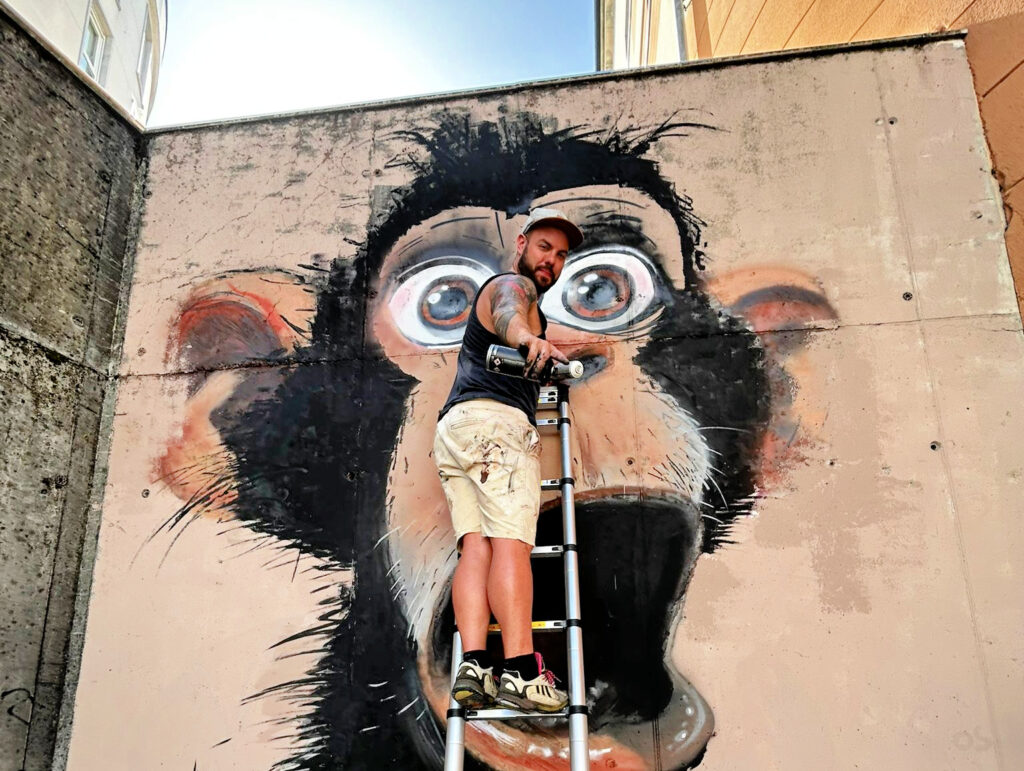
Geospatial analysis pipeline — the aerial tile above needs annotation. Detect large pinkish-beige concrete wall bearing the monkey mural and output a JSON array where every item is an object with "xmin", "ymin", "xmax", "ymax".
[{"xmin": 68, "ymin": 34, "xmax": 1024, "ymax": 771}]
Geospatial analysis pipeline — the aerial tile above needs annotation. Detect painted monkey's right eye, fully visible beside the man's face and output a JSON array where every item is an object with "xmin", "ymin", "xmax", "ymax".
[{"xmin": 541, "ymin": 245, "xmax": 660, "ymax": 332}]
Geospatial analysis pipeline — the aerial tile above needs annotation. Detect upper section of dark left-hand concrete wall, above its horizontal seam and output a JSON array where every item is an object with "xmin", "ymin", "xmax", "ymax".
[{"xmin": 0, "ymin": 15, "xmax": 138, "ymax": 372}]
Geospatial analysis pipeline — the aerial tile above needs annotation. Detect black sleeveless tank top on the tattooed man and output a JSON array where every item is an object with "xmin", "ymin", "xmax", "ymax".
[{"xmin": 437, "ymin": 273, "xmax": 548, "ymax": 426}]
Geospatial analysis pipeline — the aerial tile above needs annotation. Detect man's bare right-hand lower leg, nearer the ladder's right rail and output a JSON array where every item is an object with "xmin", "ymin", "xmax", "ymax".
[{"xmin": 487, "ymin": 539, "xmax": 534, "ymax": 658}]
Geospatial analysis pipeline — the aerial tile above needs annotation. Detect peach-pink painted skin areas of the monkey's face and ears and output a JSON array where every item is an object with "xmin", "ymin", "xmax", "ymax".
[{"xmin": 157, "ymin": 188, "xmax": 821, "ymax": 770}]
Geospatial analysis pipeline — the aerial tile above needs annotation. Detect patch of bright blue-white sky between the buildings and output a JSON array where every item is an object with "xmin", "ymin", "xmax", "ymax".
[{"xmin": 148, "ymin": 0, "xmax": 595, "ymax": 126}]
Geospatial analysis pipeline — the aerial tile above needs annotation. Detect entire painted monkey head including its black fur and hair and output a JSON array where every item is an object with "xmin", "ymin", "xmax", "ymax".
[{"xmin": 155, "ymin": 114, "xmax": 831, "ymax": 769}]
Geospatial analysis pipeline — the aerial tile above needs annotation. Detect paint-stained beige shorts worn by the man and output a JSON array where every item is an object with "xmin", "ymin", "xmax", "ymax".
[{"xmin": 434, "ymin": 399, "xmax": 541, "ymax": 546}]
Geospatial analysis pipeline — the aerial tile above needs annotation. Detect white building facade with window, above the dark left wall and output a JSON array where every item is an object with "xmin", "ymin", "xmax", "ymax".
[{"xmin": 0, "ymin": 0, "xmax": 167, "ymax": 124}]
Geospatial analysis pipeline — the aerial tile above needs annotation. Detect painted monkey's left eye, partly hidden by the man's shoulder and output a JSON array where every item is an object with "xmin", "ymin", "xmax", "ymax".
[{"xmin": 388, "ymin": 256, "xmax": 494, "ymax": 346}]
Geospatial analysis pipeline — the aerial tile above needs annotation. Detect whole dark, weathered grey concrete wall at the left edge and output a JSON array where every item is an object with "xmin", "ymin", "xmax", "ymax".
[{"xmin": 0, "ymin": 11, "xmax": 139, "ymax": 770}]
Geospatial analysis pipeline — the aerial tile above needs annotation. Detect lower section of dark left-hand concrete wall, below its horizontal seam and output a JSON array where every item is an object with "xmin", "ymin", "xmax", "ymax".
[{"xmin": 0, "ymin": 331, "xmax": 103, "ymax": 768}]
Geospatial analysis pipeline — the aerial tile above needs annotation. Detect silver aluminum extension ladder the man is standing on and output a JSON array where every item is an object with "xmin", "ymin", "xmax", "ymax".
[{"xmin": 444, "ymin": 384, "xmax": 590, "ymax": 771}]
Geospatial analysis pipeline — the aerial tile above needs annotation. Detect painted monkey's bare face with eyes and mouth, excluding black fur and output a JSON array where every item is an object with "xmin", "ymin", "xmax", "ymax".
[{"xmin": 370, "ymin": 184, "xmax": 757, "ymax": 768}]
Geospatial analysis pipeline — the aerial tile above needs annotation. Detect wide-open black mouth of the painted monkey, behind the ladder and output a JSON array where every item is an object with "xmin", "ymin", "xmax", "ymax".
[{"xmin": 432, "ymin": 496, "xmax": 713, "ymax": 769}]
